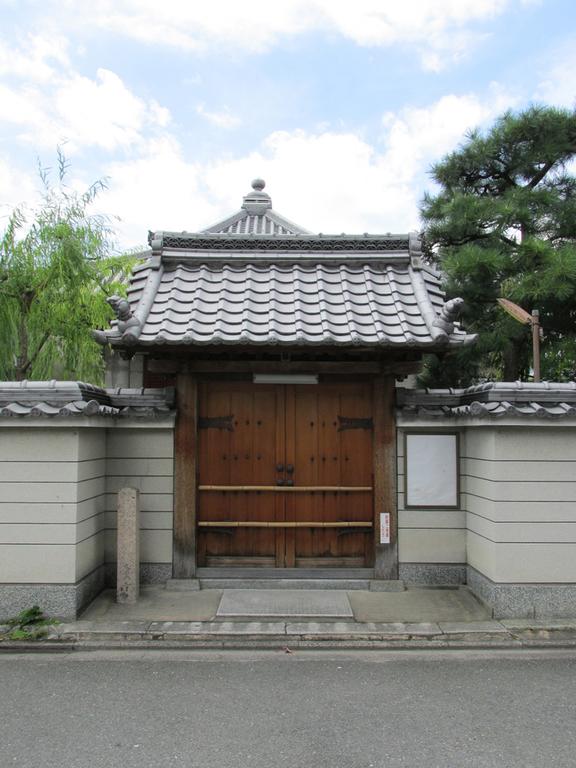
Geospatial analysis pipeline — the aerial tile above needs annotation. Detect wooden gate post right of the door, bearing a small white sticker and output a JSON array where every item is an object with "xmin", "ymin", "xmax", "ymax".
[{"xmin": 373, "ymin": 376, "xmax": 398, "ymax": 579}]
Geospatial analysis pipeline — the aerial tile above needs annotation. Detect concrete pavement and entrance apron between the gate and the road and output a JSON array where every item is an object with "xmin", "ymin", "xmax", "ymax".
[{"xmin": 0, "ymin": 586, "xmax": 576, "ymax": 651}]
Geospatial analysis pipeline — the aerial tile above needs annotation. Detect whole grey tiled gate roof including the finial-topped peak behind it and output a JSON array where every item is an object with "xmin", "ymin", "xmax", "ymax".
[{"xmin": 96, "ymin": 180, "xmax": 474, "ymax": 349}]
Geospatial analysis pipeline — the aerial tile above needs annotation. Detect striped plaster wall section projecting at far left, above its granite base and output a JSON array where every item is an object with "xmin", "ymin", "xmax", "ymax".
[{"xmin": 0, "ymin": 424, "xmax": 105, "ymax": 584}]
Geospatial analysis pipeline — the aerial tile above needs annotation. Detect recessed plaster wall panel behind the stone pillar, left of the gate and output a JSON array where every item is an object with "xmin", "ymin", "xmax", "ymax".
[{"xmin": 105, "ymin": 427, "xmax": 174, "ymax": 563}]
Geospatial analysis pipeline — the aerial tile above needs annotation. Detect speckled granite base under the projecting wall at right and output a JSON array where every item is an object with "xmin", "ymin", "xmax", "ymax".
[{"xmin": 467, "ymin": 566, "xmax": 576, "ymax": 619}]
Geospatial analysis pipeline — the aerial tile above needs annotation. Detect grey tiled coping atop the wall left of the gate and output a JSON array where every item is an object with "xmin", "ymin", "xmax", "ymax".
[{"xmin": 0, "ymin": 381, "xmax": 174, "ymax": 418}]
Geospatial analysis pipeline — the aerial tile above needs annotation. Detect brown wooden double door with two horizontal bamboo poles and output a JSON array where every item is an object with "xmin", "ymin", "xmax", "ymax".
[{"xmin": 197, "ymin": 381, "xmax": 374, "ymax": 568}]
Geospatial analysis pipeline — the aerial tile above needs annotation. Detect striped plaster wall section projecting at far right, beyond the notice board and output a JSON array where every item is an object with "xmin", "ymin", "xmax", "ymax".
[{"xmin": 462, "ymin": 425, "xmax": 576, "ymax": 583}]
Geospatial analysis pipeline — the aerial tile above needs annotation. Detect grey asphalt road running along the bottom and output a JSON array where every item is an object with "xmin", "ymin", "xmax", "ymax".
[{"xmin": 0, "ymin": 651, "xmax": 576, "ymax": 768}]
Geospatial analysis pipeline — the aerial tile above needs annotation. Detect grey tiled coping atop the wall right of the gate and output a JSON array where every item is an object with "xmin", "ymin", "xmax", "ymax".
[{"xmin": 397, "ymin": 382, "xmax": 576, "ymax": 420}]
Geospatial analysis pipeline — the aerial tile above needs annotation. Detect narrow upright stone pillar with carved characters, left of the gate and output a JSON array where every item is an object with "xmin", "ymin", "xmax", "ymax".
[{"xmin": 116, "ymin": 488, "xmax": 140, "ymax": 605}]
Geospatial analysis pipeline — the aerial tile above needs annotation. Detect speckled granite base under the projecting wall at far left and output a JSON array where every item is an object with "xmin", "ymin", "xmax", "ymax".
[{"xmin": 0, "ymin": 565, "xmax": 105, "ymax": 621}]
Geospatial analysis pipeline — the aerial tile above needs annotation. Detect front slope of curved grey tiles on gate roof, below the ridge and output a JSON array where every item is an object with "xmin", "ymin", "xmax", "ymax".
[{"xmin": 132, "ymin": 262, "xmax": 464, "ymax": 347}]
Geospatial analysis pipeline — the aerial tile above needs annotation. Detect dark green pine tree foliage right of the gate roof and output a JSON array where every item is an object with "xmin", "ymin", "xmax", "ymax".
[{"xmin": 422, "ymin": 106, "xmax": 576, "ymax": 386}]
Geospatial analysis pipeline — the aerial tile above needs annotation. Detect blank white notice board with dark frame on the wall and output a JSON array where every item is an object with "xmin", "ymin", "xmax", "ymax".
[{"xmin": 405, "ymin": 433, "xmax": 458, "ymax": 508}]
